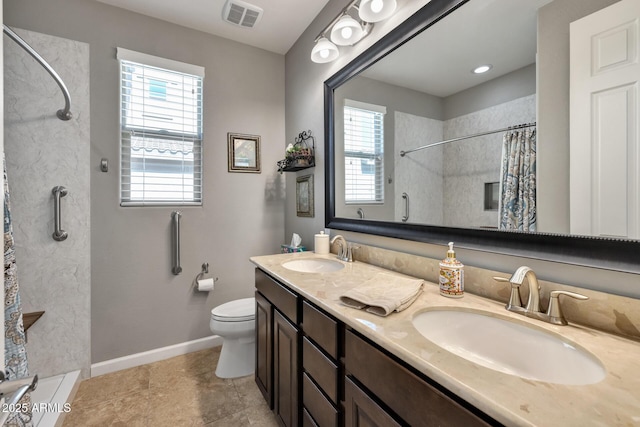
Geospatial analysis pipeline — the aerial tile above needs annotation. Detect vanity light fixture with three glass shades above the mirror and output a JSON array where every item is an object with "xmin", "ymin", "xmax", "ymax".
[{"xmin": 311, "ymin": 0, "xmax": 397, "ymax": 64}]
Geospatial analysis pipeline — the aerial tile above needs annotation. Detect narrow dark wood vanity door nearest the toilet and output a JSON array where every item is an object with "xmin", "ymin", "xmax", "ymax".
[{"xmin": 256, "ymin": 292, "xmax": 273, "ymax": 409}]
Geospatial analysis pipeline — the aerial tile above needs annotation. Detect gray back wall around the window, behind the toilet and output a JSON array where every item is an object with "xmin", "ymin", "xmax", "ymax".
[{"xmin": 4, "ymin": 0, "xmax": 286, "ymax": 363}]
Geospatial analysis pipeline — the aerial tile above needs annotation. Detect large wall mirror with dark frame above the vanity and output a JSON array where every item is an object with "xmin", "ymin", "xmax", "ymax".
[{"xmin": 325, "ymin": 0, "xmax": 640, "ymax": 273}]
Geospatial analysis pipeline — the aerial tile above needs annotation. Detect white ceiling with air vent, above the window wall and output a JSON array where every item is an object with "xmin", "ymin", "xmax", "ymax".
[{"xmin": 92, "ymin": 0, "xmax": 329, "ymax": 54}]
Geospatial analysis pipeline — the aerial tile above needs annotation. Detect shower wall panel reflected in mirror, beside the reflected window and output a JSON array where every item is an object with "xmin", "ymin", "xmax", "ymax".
[{"xmin": 394, "ymin": 111, "xmax": 444, "ymax": 224}]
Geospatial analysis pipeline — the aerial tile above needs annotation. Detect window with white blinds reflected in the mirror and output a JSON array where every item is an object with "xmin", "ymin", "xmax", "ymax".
[{"xmin": 344, "ymin": 100, "xmax": 386, "ymax": 204}]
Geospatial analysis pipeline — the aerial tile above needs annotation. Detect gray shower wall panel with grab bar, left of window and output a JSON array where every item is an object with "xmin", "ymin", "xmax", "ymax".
[{"xmin": 4, "ymin": 30, "xmax": 91, "ymax": 377}]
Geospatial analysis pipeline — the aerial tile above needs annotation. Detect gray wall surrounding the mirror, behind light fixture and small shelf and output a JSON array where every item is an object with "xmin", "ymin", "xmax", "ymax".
[{"xmin": 282, "ymin": 0, "xmax": 640, "ymax": 298}]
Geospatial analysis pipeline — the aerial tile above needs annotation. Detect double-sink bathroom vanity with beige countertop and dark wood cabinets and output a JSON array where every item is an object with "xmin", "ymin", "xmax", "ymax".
[{"xmin": 251, "ymin": 253, "xmax": 640, "ymax": 426}]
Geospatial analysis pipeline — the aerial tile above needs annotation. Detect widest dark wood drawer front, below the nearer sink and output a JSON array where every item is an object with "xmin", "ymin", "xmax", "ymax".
[{"xmin": 345, "ymin": 330, "xmax": 491, "ymax": 426}]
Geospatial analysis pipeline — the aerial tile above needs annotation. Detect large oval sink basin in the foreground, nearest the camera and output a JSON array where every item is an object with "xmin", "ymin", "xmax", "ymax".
[{"xmin": 413, "ymin": 310, "xmax": 606, "ymax": 385}]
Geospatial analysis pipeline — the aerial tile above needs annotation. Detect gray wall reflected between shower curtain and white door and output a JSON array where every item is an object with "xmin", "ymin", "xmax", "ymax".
[{"xmin": 538, "ymin": 0, "xmax": 618, "ymax": 233}]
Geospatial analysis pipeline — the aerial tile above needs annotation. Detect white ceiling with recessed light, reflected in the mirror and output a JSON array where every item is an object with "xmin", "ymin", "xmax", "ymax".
[{"xmin": 362, "ymin": 0, "xmax": 551, "ymax": 97}]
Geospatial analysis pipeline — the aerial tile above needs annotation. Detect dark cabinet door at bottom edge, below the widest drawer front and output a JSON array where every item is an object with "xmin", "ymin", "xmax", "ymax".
[{"xmin": 344, "ymin": 377, "xmax": 400, "ymax": 427}]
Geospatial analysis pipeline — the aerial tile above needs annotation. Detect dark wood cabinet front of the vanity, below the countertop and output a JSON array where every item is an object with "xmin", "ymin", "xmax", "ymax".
[{"xmin": 255, "ymin": 269, "xmax": 499, "ymax": 427}]
